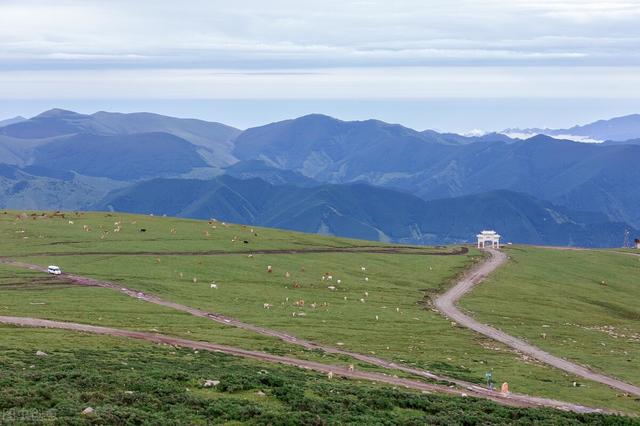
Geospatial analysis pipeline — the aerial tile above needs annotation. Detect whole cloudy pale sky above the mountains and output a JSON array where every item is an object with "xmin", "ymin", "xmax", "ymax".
[{"xmin": 0, "ymin": 0, "xmax": 640, "ymax": 132}]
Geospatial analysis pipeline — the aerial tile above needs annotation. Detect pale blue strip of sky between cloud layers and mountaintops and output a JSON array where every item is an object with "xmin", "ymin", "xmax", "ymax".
[{"xmin": 0, "ymin": 98, "xmax": 640, "ymax": 133}]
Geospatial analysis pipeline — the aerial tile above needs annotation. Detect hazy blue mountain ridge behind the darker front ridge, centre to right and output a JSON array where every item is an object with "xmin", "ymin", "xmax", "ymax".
[{"xmin": 233, "ymin": 115, "xmax": 640, "ymax": 226}]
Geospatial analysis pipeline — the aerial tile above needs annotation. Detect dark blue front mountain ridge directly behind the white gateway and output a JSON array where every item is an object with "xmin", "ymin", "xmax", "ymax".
[{"xmin": 94, "ymin": 176, "xmax": 628, "ymax": 246}]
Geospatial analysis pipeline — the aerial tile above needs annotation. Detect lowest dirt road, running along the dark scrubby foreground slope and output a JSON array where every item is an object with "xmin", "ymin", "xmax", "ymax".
[{"xmin": 0, "ymin": 316, "xmax": 603, "ymax": 413}]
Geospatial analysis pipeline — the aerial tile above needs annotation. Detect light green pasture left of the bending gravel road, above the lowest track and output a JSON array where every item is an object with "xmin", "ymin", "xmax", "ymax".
[{"xmin": 0, "ymin": 212, "xmax": 640, "ymax": 413}]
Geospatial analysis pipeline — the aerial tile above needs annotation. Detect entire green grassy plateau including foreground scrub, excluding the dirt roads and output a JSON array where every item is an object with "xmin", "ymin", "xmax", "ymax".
[{"xmin": 0, "ymin": 212, "xmax": 640, "ymax": 424}]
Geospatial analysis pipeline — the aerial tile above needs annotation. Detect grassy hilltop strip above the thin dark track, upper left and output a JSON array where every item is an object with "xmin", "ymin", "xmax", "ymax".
[{"xmin": 0, "ymin": 211, "xmax": 398, "ymax": 255}]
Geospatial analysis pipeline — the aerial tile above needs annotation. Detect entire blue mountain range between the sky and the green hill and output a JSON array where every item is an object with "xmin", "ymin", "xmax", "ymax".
[{"xmin": 0, "ymin": 109, "xmax": 640, "ymax": 246}]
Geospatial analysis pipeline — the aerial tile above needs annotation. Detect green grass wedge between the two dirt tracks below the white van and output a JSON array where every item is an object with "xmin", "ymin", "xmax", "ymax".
[{"xmin": 0, "ymin": 265, "xmax": 339, "ymax": 363}]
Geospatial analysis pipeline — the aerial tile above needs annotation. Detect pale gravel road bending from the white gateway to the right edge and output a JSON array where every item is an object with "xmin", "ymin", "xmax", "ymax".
[{"xmin": 434, "ymin": 249, "xmax": 640, "ymax": 396}]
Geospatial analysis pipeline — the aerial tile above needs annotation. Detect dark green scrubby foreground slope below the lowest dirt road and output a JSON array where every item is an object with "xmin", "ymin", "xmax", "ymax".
[{"xmin": 0, "ymin": 326, "xmax": 634, "ymax": 426}]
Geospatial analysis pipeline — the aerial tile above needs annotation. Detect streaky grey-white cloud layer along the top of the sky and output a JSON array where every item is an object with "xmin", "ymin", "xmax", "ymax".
[{"xmin": 0, "ymin": 0, "xmax": 640, "ymax": 68}]
